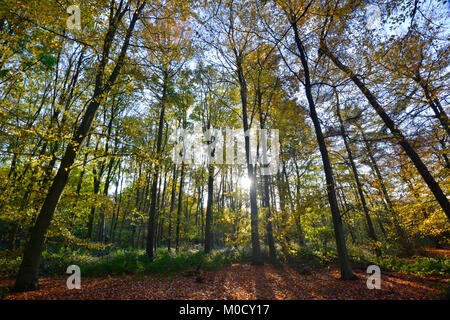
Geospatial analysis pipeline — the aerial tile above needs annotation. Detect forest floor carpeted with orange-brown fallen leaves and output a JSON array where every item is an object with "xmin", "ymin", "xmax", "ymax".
[{"xmin": 0, "ymin": 263, "xmax": 450, "ymax": 300}]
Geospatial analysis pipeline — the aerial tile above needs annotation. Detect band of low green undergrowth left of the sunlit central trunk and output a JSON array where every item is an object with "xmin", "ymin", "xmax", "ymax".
[{"xmin": 0, "ymin": 248, "xmax": 240, "ymax": 277}]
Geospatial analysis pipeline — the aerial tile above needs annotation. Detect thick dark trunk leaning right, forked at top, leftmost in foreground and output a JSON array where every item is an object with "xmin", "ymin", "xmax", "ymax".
[{"xmin": 14, "ymin": 1, "xmax": 145, "ymax": 291}]
